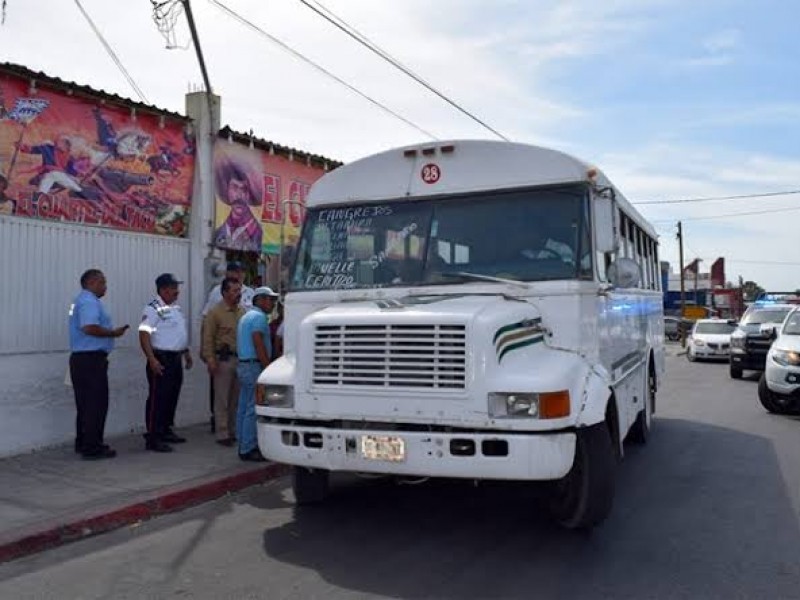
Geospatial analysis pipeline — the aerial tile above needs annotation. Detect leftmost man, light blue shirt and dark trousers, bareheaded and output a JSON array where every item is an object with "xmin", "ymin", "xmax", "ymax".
[{"xmin": 69, "ymin": 269, "xmax": 128, "ymax": 460}]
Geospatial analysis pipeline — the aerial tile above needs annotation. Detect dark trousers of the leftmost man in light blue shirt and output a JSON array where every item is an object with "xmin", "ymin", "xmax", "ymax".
[{"xmin": 69, "ymin": 352, "xmax": 108, "ymax": 454}]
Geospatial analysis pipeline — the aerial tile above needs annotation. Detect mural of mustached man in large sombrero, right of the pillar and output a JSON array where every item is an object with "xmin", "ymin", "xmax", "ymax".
[{"xmin": 213, "ymin": 138, "xmax": 325, "ymax": 254}]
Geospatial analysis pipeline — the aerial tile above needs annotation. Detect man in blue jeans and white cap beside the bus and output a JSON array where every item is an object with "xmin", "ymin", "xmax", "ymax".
[{"xmin": 236, "ymin": 287, "xmax": 278, "ymax": 462}]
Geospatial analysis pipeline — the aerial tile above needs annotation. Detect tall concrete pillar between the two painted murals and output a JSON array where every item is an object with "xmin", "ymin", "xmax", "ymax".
[{"xmin": 183, "ymin": 92, "xmax": 221, "ymax": 347}]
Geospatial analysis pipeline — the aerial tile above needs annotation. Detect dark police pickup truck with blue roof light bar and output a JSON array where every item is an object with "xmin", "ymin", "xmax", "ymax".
[{"xmin": 730, "ymin": 301, "xmax": 797, "ymax": 379}]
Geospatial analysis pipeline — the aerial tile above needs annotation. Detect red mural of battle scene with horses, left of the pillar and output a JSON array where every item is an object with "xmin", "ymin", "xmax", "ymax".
[{"xmin": 0, "ymin": 77, "xmax": 195, "ymax": 237}]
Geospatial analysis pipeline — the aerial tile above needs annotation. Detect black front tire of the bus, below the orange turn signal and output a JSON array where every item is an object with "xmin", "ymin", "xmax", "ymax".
[{"xmin": 548, "ymin": 422, "xmax": 616, "ymax": 529}]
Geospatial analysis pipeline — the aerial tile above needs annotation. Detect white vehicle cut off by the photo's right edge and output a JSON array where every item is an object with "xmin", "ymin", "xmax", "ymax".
[{"xmin": 758, "ymin": 307, "xmax": 800, "ymax": 414}]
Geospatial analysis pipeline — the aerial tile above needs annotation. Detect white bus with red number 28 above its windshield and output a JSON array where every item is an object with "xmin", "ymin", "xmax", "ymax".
[{"xmin": 256, "ymin": 140, "xmax": 664, "ymax": 528}]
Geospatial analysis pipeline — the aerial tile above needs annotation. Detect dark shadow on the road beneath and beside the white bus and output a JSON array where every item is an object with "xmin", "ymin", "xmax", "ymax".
[{"xmin": 263, "ymin": 419, "xmax": 800, "ymax": 598}]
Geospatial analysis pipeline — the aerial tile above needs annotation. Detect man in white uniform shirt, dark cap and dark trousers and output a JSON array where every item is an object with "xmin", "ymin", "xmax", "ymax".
[{"xmin": 139, "ymin": 273, "xmax": 192, "ymax": 452}]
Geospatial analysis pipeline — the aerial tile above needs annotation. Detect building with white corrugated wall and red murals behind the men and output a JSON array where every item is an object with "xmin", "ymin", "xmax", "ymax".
[{"xmin": 0, "ymin": 63, "xmax": 339, "ymax": 456}]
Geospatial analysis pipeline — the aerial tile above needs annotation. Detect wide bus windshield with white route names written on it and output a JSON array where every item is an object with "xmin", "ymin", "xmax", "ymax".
[{"xmin": 290, "ymin": 184, "xmax": 592, "ymax": 290}]
